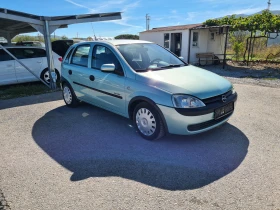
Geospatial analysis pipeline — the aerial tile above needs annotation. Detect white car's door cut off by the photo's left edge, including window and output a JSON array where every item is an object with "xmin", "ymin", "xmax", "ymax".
[{"xmin": 0, "ymin": 49, "xmax": 17, "ymax": 85}]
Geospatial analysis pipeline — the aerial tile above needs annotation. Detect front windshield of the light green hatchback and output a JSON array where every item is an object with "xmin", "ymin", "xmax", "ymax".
[{"xmin": 117, "ymin": 43, "xmax": 186, "ymax": 72}]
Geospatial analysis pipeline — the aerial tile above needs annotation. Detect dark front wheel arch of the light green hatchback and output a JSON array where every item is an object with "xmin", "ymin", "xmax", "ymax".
[{"xmin": 128, "ymin": 96, "xmax": 168, "ymax": 133}]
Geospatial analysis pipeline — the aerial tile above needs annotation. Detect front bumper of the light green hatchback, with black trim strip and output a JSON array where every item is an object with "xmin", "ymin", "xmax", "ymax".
[{"xmin": 158, "ymin": 94, "xmax": 237, "ymax": 135}]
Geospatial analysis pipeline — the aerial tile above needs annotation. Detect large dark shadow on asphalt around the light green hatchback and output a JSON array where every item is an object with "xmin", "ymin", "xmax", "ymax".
[{"xmin": 32, "ymin": 104, "xmax": 249, "ymax": 190}]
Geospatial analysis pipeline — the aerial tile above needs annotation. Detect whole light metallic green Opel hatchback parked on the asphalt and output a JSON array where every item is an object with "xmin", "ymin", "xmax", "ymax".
[{"xmin": 61, "ymin": 40, "xmax": 237, "ymax": 140}]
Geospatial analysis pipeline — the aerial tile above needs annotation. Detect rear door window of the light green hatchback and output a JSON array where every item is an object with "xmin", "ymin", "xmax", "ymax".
[{"xmin": 71, "ymin": 45, "xmax": 90, "ymax": 67}]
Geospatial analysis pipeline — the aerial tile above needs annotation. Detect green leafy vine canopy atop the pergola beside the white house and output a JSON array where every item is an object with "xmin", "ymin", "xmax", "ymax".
[{"xmin": 203, "ymin": 10, "xmax": 280, "ymax": 34}]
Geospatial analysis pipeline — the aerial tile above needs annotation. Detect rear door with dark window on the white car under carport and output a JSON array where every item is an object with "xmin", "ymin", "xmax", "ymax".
[{"xmin": 13, "ymin": 48, "xmax": 46, "ymax": 82}]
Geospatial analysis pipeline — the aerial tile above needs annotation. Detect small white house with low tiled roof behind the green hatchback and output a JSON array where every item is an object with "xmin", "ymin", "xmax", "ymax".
[{"xmin": 140, "ymin": 24, "xmax": 229, "ymax": 64}]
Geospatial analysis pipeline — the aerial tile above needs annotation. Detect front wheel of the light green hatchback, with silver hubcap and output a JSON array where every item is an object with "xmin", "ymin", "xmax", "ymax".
[{"xmin": 133, "ymin": 102, "xmax": 165, "ymax": 141}]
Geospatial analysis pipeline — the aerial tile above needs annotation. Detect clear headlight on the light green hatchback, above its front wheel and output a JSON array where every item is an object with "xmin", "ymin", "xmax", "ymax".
[{"xmin": 172, "ymin": 95, "xmax": 205, "ymax": 108}]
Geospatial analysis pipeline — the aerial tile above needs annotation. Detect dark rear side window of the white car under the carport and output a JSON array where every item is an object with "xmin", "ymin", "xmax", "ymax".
[{"xmin": 8, "ymin": 48, "xmax": 46, "ymax": 59}]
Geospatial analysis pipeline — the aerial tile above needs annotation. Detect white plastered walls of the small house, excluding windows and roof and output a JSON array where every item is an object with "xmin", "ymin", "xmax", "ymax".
[{"xmin": 139, "ymin": 29, "xmax": 225, "ymax": 64}]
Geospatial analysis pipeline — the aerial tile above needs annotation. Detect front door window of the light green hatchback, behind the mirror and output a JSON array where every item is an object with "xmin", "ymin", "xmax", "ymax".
[{"xmin": 91, "ymin": 45, "xmax": 123, "ymax": 74}]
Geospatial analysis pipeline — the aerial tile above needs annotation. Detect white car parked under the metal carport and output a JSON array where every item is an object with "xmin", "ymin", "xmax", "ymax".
[{"xmin": 0, "ymin": 46, "xmax": 62, "ymax": 85}]
